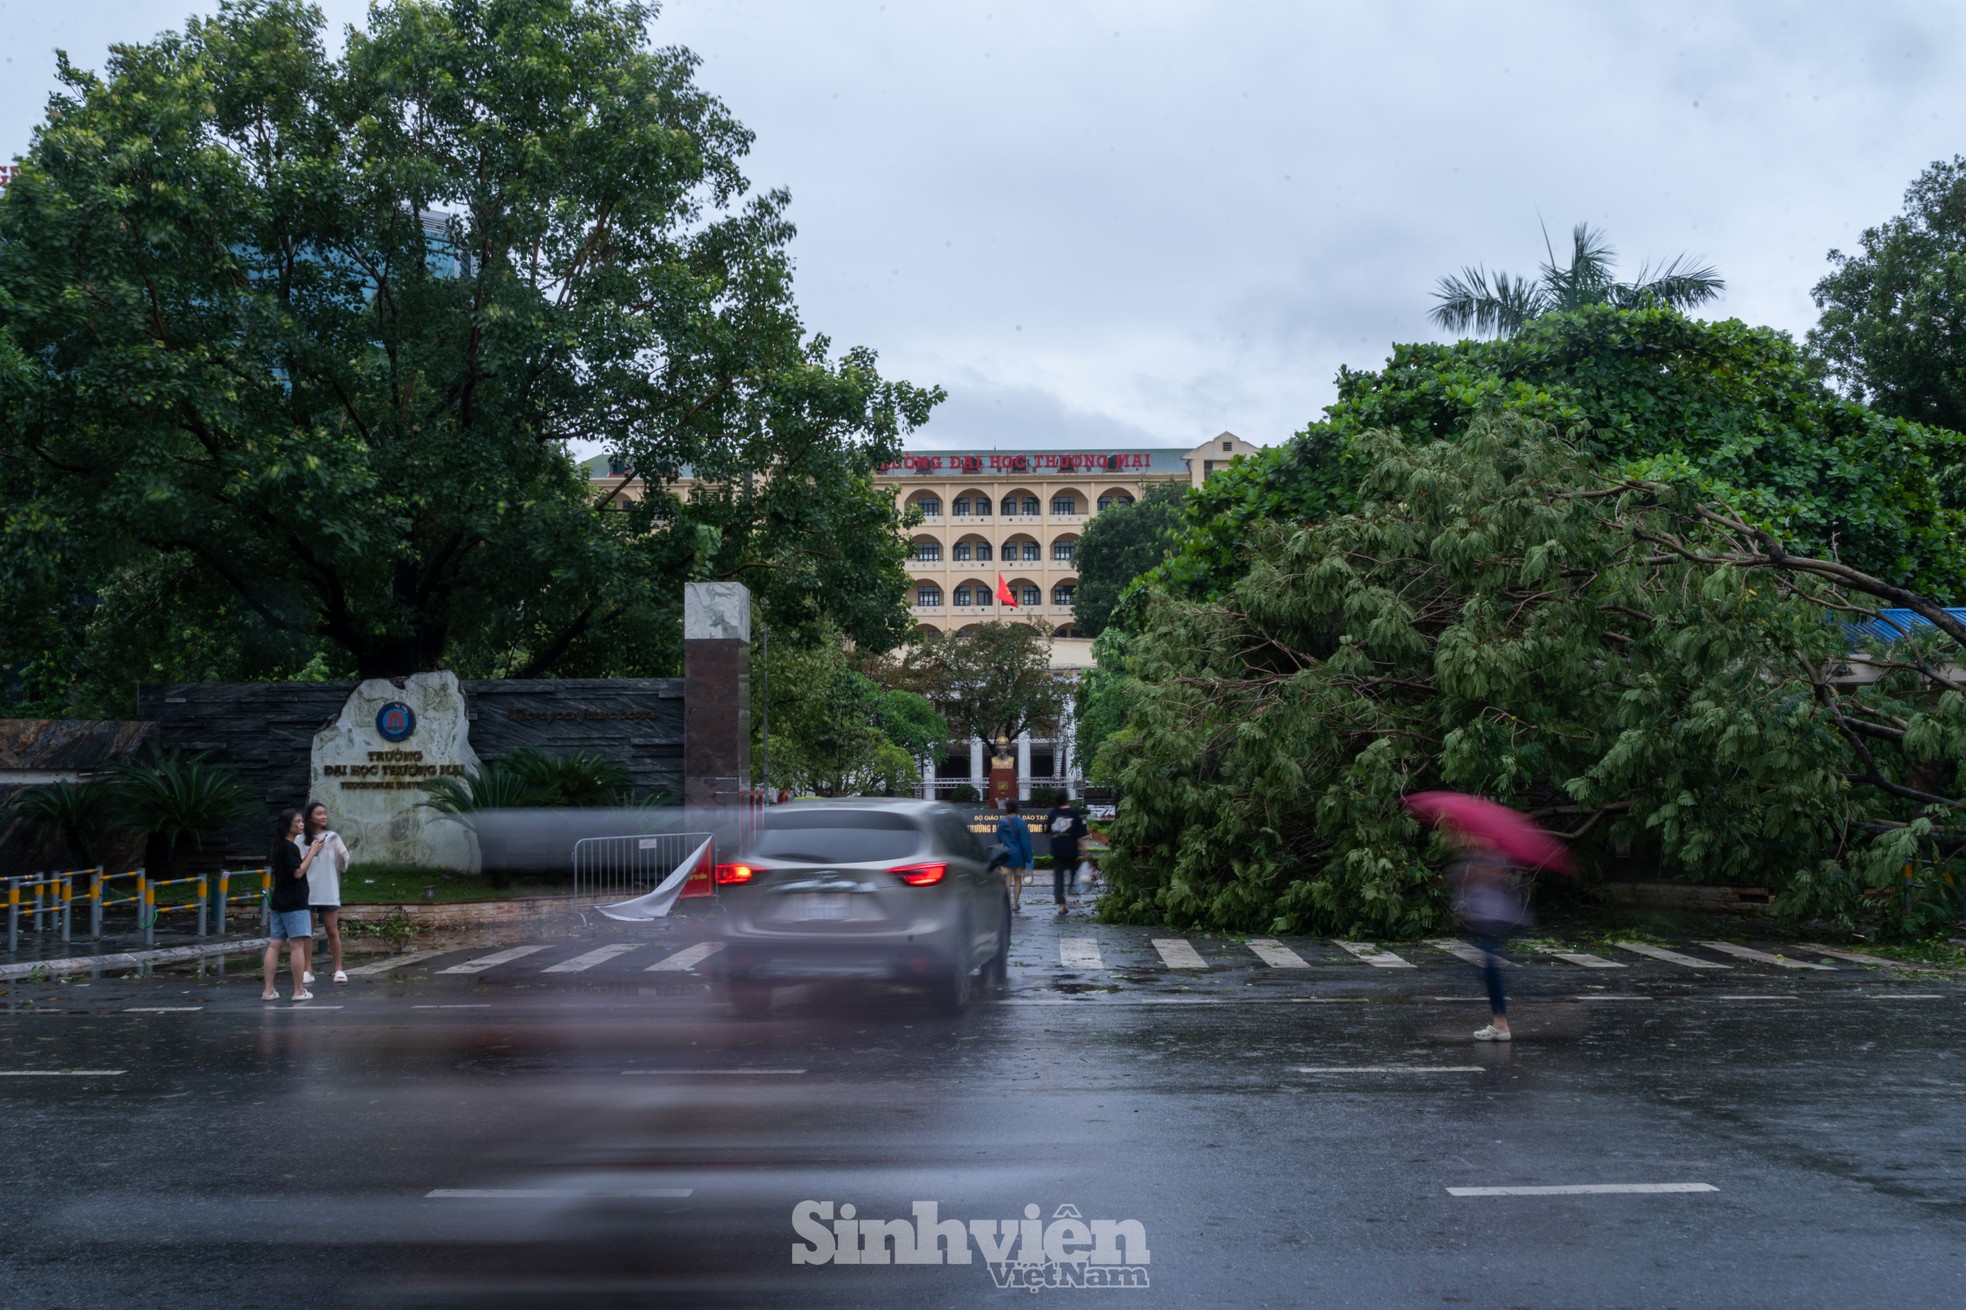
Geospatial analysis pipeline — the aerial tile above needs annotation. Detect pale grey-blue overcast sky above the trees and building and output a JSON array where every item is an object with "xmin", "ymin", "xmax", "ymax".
[{"xmin": 0, "ymin": 0, "xmax": 1966, "ymax": 447}]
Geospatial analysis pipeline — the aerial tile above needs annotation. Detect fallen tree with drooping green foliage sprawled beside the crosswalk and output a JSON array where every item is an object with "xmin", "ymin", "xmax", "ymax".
[{"xmin": 1099, "ymin": 413, "xmax": 1966, "ymax": 936}]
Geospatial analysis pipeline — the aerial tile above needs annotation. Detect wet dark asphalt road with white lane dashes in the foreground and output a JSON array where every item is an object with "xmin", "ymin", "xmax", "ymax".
[{"xmin": 0, "ymin": 915, "xmax": 1966, "ymax": 1310}]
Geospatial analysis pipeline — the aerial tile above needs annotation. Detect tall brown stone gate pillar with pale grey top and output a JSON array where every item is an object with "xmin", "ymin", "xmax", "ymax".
[{"xmin": 682, "ymin": 582, "xmax": 751, "ymax": 804}]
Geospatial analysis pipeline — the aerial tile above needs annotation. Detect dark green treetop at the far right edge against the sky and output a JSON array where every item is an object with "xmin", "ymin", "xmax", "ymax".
[{"xmin": 1809, "ymin": 155, "xmax": 1966, "ymax": 440}]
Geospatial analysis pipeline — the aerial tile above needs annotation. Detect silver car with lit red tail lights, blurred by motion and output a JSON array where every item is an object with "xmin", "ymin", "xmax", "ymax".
[{"xmin": 712, "ymin": 801, "xmax": 1011, "ymax": 1015}]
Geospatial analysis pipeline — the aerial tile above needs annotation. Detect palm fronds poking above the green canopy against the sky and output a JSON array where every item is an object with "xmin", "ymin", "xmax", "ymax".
[{"xmin": 1429, "ymin": 222, "xmax": 1726, "ymax": 336}]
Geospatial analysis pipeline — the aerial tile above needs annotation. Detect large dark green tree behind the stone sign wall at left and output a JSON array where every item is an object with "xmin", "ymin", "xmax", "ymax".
[{"xmin": 0, "ymin": 0, "xmax": 940, "ymax": 700}]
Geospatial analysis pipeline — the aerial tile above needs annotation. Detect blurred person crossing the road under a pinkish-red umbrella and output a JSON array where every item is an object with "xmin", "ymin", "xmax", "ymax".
[{"xmin": 1406, "ymin": 791, "xmax": 1571, "ymax": 1042}]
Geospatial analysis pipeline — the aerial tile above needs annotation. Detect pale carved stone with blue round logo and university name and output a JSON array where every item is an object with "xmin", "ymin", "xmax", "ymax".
[{"xmin": 309, "ymin": 673, "xmax": 478, "ymax": 869}]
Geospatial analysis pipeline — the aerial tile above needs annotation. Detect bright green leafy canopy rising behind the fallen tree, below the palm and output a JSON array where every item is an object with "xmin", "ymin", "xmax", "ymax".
[{"xmin": 1154, "ymin": 307, "xmax": 1966, "ymax": 600}]
